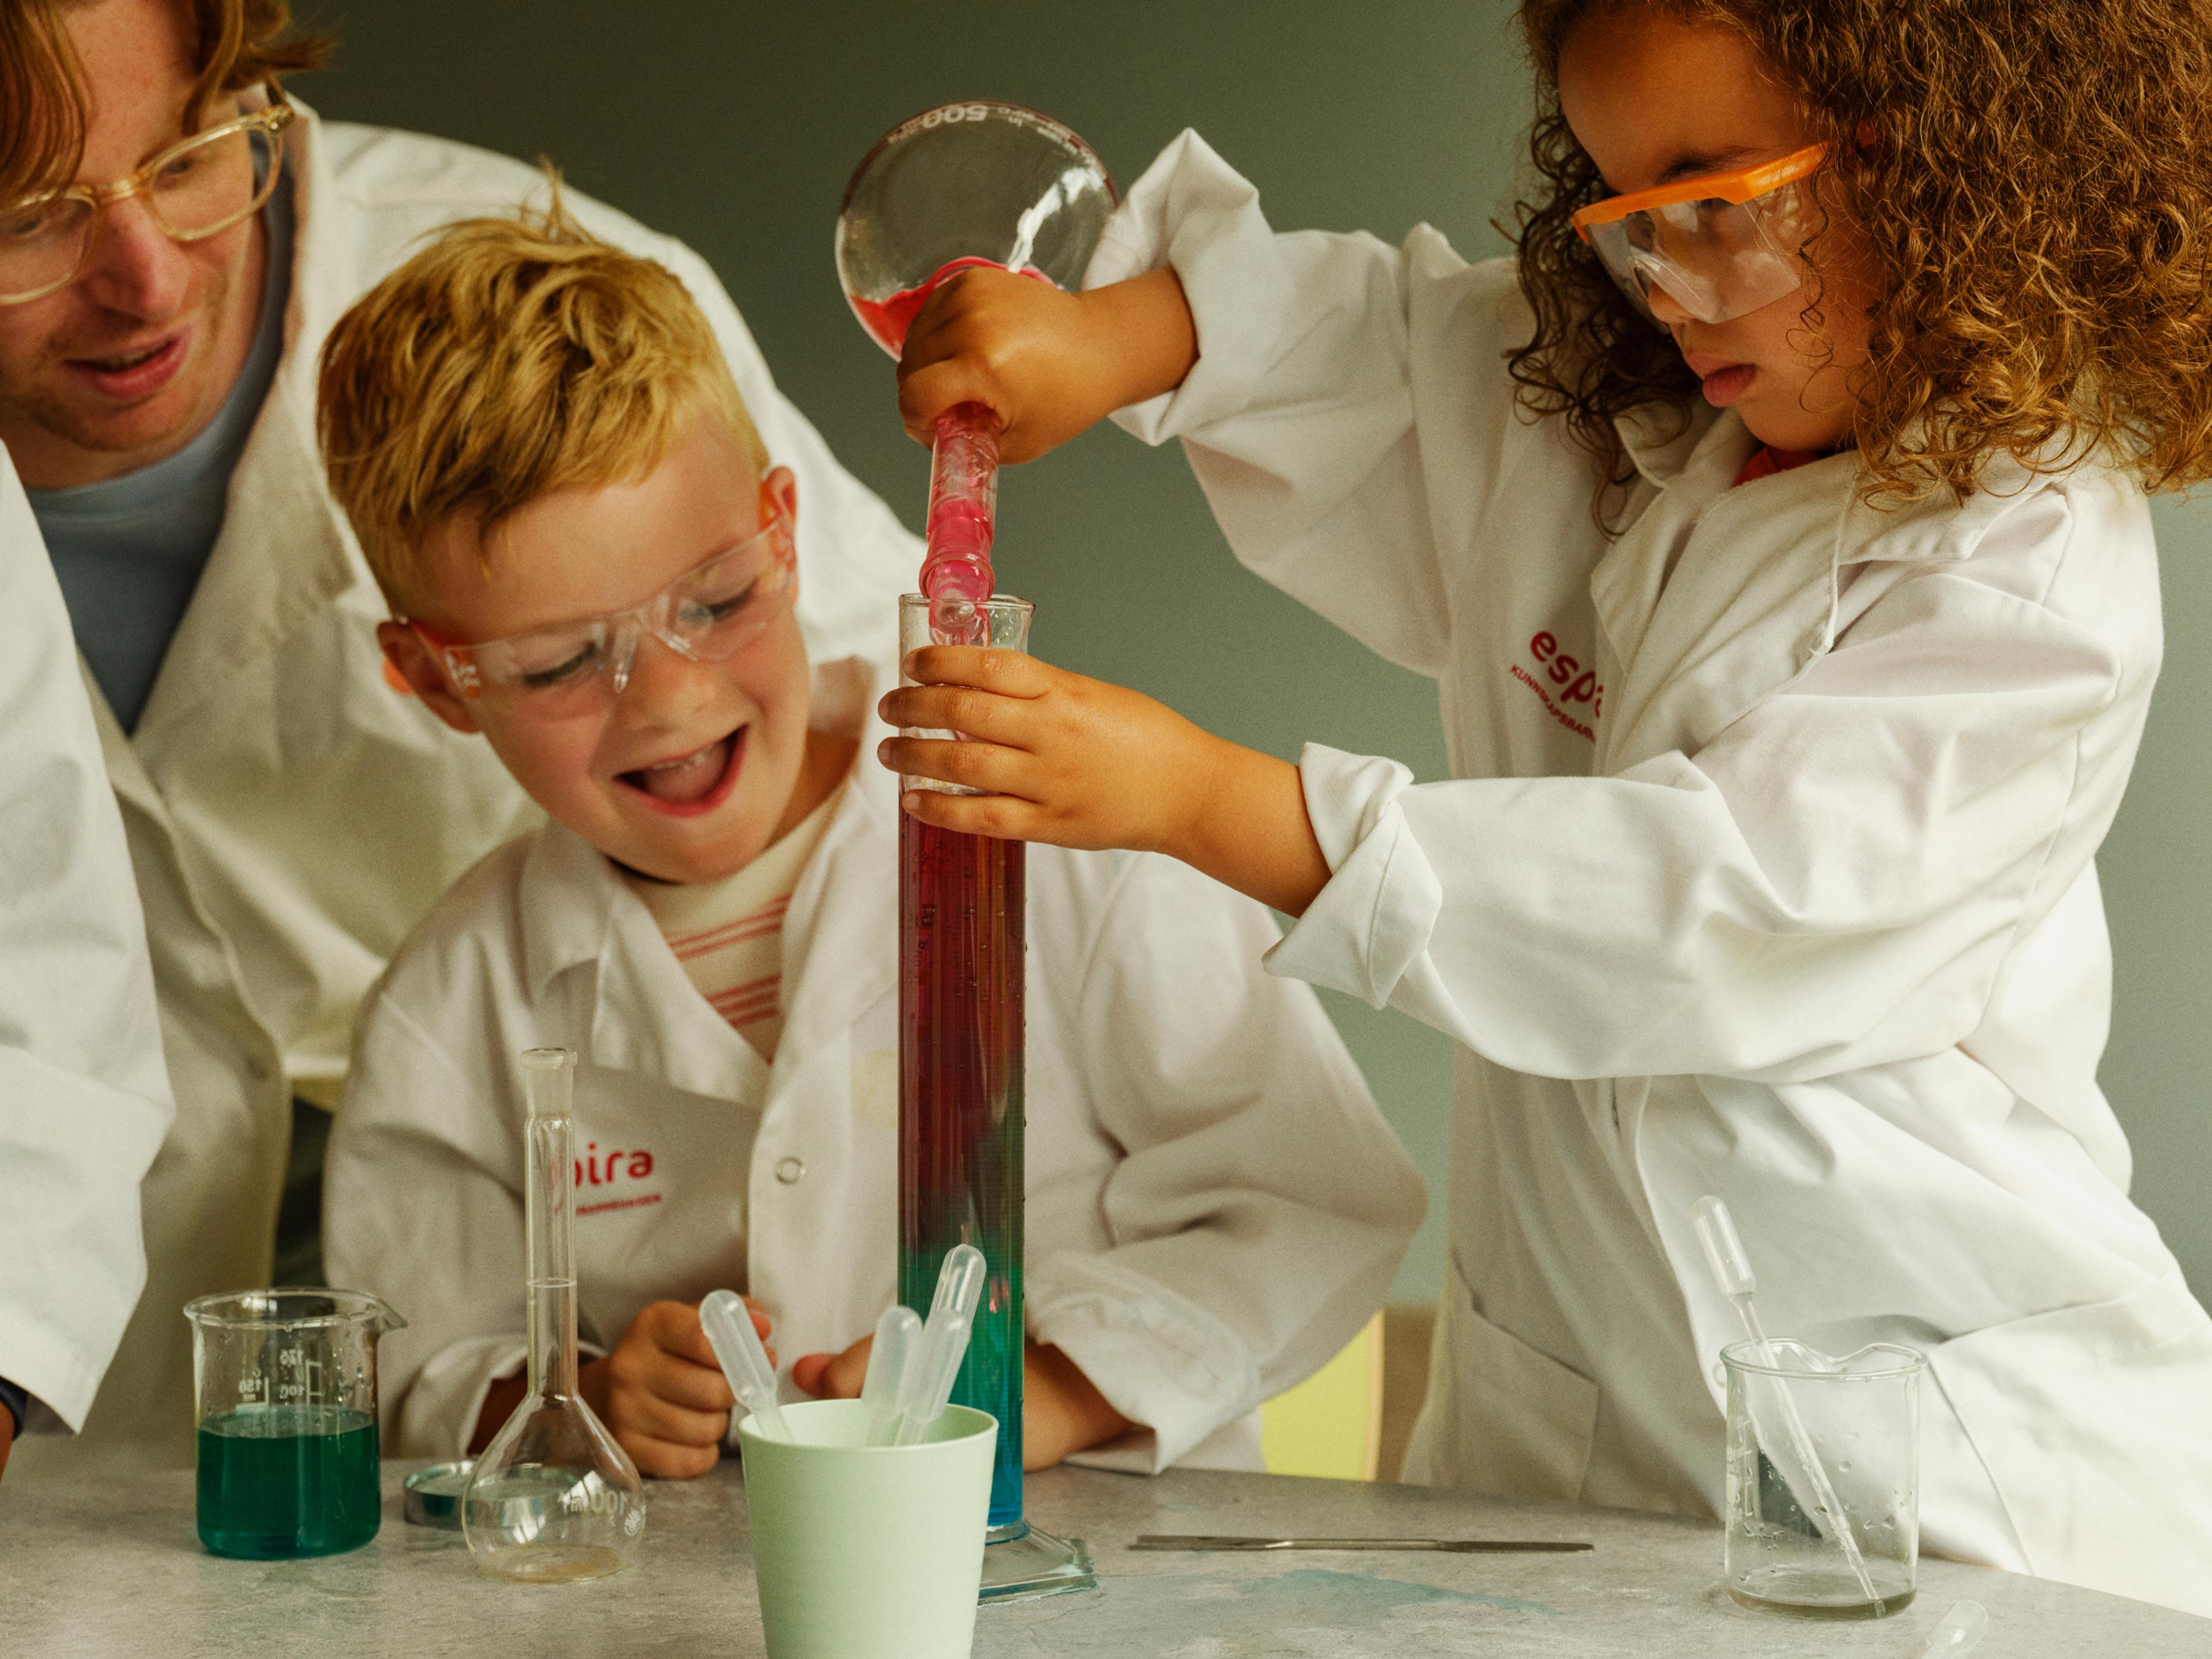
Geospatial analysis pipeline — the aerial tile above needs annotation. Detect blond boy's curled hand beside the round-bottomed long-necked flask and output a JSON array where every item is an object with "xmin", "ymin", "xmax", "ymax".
[{"xmin": 582, "ymin": 1301, "xmax": 777, "ymax": 1480}]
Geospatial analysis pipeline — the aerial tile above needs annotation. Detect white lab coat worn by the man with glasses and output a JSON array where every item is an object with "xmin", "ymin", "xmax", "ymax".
[{"xmin": 9, "ymin": 100, "xmax": 920, "ymax": 1480}]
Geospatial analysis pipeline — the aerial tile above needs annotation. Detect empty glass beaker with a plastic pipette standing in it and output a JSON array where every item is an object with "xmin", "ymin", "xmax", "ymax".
[{"xmin": 1721, "ymin": 1338, "xmax": 1927, "ymax": 1619}]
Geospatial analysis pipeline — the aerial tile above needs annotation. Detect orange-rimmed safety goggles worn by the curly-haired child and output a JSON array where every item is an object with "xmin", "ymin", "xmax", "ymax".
[{"xmin": 1573, "ymin": 144, "xmax": 1827, "ymax": 323}]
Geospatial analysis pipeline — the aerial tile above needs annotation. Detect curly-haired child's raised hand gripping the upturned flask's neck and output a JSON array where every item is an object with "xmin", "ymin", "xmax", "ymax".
[{"xmin": 898, "ymin": 268, "xmax": 1199, "ymax": 463}]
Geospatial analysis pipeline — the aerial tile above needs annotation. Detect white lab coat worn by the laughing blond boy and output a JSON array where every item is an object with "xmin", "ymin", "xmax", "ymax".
[{"xmin": 323, "ymin": 661, "xmax": 1425, "ymax": 1471}]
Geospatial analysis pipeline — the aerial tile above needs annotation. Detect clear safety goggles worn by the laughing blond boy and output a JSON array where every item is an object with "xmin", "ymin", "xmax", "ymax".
[{"xmin": 398, "ymin": 467, "xmax": 798, "ymax": 719}]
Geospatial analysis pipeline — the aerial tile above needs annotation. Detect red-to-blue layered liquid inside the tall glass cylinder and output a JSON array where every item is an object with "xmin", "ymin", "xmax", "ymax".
[{"xmin": 898, "ymin": 814, "xmax": 1027, "ymax": 1528}]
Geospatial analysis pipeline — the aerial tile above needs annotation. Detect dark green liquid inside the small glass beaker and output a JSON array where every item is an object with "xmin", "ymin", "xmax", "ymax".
[{"xmin": 199, "ymin": 1404, "xmax": 380, "ymax": 1562}]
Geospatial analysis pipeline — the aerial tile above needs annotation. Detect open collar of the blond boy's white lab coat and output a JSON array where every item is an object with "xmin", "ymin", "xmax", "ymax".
[{"xmin": 520, "ymin": 657, "xmax": 898, "ymax": 1097}]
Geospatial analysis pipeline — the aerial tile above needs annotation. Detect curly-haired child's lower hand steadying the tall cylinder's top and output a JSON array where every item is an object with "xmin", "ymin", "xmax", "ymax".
[{"xmin": 876, "ymin": 646, "xmax": 1330, "ymax": 916}]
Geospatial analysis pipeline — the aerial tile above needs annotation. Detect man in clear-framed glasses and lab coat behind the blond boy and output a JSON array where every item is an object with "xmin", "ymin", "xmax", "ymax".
[{"xmin": 0, "ymin": 0, "xmax": 920, "ymax": 1478}]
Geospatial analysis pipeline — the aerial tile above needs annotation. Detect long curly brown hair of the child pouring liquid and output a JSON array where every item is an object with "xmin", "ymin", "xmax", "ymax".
[{"xmin": 1509, "ymin": 0, "xmax": 2212, "ymax": 502}]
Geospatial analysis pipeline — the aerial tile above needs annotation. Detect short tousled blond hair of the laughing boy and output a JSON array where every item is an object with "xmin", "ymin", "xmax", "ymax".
[{"xmin": 316, "ymin": 194, "xmax": 767, "ymax": 613}]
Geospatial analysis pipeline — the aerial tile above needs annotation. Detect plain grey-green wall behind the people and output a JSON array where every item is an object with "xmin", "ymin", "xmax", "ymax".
[{"xmin": 297, "ymin": 0, "xmax": 2212, "ymax": 1303}]
